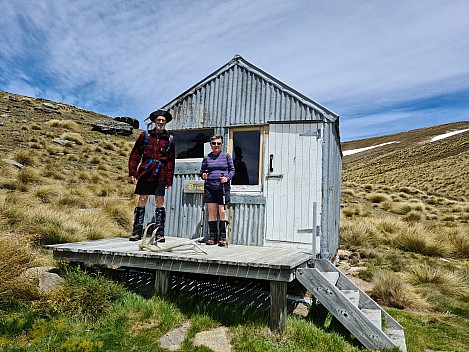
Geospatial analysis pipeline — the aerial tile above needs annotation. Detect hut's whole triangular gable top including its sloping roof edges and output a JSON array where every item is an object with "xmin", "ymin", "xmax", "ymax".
[{"xmin": 146, "ymin": 55, "xmax": 339, "ymax": 127}]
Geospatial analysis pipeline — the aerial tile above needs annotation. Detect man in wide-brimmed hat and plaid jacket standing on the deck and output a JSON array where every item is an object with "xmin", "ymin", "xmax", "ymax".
[{"xmin": 129, "ymin": 110, "xmax": 175, "ymax": 242}]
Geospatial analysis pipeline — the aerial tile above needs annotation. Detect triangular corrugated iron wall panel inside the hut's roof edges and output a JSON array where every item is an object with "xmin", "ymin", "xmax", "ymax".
[{"xmin": 164, "ymin": 65, "xmax": 330, "ymax": 130}]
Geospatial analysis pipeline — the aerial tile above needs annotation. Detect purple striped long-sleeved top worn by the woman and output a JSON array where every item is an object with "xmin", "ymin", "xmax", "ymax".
[{"xmin": 199, "ymin": 152, "xmax": 234, "ymax": 191}]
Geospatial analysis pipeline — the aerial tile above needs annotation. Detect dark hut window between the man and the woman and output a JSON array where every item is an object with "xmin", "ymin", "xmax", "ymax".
[{"xmin": 170, "ymin": 128, "xmax": 214, "ymax": 159}]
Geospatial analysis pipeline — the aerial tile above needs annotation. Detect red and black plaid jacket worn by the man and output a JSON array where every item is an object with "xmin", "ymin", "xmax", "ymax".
[{"xmin": 129, "ymin": 129, "xmax": 176, "ymax": 186}]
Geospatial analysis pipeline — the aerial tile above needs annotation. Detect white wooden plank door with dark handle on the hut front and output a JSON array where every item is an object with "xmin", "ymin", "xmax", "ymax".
[{"xmin": 264, "ymin": 123, "xmax": 322, "ymax": 249}]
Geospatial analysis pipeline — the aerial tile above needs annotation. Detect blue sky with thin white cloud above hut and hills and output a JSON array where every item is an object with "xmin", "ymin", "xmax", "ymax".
[{"xmin": 0, "ymin": 0, "xmax": 469, "ymax": 141}]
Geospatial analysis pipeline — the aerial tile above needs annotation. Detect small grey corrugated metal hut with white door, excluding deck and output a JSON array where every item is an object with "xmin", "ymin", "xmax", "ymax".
[{"xmin": 145, "ymin": 55, "xmax": 342, "ymax": 259}]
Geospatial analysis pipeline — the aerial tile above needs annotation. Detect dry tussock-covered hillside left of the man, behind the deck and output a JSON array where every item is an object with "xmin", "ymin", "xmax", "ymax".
[{"xmin": 0, "ymin": 92, "xmax": 136, "ymax": 244}]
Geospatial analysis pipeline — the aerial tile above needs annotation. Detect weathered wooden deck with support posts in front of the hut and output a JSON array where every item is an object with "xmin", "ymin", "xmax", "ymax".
[{"xmin": 46, "ymin": 237, "xmax": 313, "ymax": 331}]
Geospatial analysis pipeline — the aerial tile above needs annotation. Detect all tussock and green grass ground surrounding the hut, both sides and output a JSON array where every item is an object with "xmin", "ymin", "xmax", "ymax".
[{"xmin": 0, "ymin": 91, "xmax": 469, "ymax": 352}]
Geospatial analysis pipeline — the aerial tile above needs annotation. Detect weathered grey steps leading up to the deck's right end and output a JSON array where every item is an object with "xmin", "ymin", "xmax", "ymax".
[{"xmin": 296, "ymin": 259, "xmax": 407, "ymax": 352}]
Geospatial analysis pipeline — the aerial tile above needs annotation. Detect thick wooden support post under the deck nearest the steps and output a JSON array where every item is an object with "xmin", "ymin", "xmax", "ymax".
[{"xmin": 270, "ymin": 281, "xmax": 287, "ymax": 332}]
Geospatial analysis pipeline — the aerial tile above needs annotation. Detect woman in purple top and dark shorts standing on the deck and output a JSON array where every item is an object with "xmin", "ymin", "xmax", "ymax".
[{"xmin": 200, "ymin": 135, "xmax": 235, "ymax": 247}]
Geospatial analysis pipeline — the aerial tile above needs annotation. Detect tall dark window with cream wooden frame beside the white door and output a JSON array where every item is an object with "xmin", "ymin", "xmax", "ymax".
[{"xmin": 230, "ymin": 127, "xmax": 263, "ymax": 191}]
